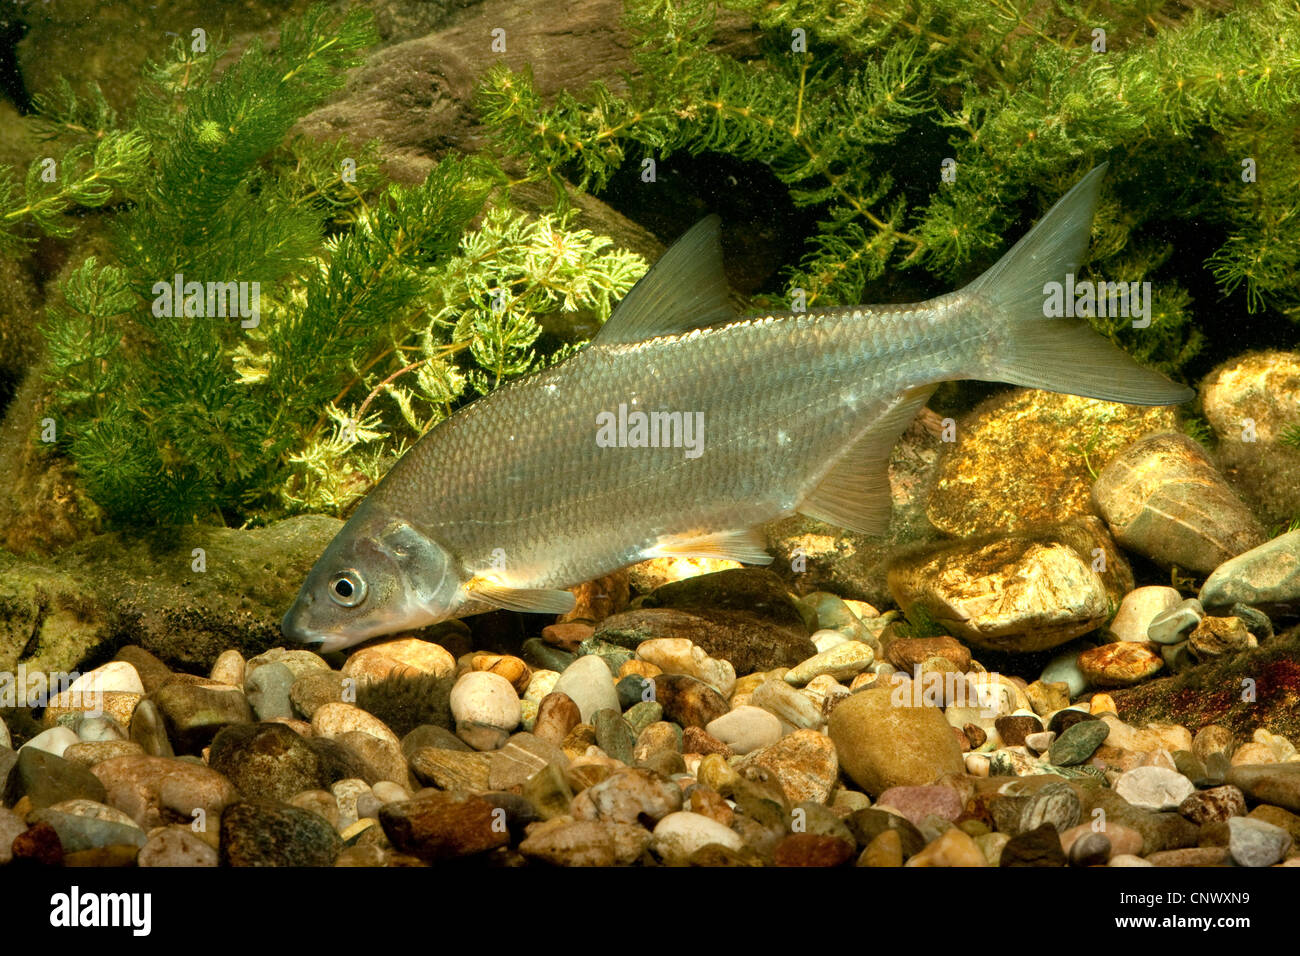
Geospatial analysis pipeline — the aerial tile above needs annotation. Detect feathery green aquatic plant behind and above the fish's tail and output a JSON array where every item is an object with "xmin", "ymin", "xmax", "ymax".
[{"xmin": 480, "ymin": 0, "xmax": 1300, "ymax": 371}]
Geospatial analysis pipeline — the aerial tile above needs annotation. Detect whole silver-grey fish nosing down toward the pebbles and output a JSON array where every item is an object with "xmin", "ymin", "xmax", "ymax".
[{"xmin": 281, "ymin": 165, "xmax": 1195, "ymax": 653}]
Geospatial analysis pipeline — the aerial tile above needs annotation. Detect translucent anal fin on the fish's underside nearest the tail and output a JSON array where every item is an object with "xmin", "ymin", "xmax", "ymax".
[{"xmin": 798, "ymin": 385, "xmax": 937, "ymax": 535}]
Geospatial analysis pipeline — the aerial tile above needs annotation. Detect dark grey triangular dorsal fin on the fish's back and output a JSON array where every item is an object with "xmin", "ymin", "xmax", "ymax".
[{"xmin": 593, "ymin": 216, "xmax": 736, "ymax": 345}]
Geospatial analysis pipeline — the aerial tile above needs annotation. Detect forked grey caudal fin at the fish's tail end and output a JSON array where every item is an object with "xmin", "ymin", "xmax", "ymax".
[{"xmin": 963, "ymin": 164, "xmax": 1196, "ymax": 405}]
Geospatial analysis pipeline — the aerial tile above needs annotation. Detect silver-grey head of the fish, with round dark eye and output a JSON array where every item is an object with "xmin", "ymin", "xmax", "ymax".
[{"xmin": 280, "ymin": 505, "xmax": 465, "ymax": 653}]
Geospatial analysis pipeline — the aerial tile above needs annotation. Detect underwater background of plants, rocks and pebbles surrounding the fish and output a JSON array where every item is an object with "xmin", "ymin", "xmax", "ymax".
[{"xmin": 0, "ymin": 0, "xmax": 1300, "ymax": 865}]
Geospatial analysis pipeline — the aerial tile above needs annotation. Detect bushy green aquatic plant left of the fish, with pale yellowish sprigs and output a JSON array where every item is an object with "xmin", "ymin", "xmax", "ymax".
[{"xmin": 0, "ymin": 7, "xmax": 645, "ymax": 524}]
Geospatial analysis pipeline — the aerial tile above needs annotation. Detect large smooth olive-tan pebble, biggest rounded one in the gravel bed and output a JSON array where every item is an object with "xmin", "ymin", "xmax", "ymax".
[{"xmin": 832, "ymin": 688, "xmax": 965, "ymax": 797}]
